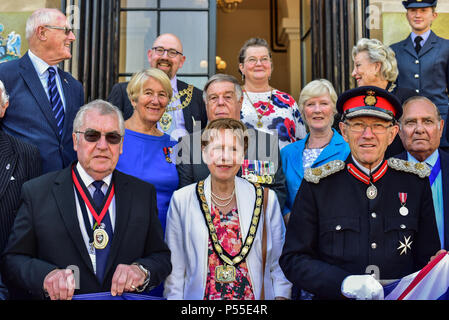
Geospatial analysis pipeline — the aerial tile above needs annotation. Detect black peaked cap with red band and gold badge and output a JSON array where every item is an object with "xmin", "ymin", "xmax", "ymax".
[{"xmin": 337, "ymin": 86, "xmax": 402, "ymax": 121}]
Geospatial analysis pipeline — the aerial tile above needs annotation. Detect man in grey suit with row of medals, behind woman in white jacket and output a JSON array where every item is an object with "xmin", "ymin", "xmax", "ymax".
[{"xmin": 176, "ymin": 74, "xmax": 287, "ymax": 215}]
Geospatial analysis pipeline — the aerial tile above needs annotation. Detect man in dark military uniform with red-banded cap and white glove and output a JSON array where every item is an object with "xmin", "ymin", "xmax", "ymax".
[{"xmin": 279, "ymin": 87, "xmax": 440, "ymax": 299}]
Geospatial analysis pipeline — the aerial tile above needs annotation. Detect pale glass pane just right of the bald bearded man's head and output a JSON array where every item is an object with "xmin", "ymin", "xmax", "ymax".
[{"xmin": 161, "ymin": 11, "xmax": 208, "ymax": 74}]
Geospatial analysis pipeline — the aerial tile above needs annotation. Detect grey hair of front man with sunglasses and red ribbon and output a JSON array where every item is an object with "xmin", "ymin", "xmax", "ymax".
[{"xmin": 73, "ymin": 99, "xmax": 125, "ymax": 136}]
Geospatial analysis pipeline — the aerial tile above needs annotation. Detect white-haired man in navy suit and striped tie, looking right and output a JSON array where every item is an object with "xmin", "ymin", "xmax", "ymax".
[{"xmin": 0, "ymin": 9, "xmax": 84, "ymax": 173}]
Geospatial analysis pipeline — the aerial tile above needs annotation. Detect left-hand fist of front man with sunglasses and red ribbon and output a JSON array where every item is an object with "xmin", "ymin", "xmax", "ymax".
[{"xmin": 44, "ymin": 269, "xmax": 75, "ymax": 300}]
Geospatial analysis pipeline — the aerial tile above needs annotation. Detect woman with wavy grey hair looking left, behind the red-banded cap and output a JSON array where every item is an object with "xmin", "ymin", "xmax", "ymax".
[{"xmin": 352, "ymin": 38, "xmax": 417, "ymax": 158}]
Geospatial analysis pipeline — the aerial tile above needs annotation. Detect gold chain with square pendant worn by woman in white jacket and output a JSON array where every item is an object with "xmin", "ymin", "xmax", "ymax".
[{"xmin": 197, "ymin": 181, "xmax": 263, "ymax": 283}]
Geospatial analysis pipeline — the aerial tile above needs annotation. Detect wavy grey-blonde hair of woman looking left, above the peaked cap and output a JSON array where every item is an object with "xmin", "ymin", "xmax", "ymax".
[{"xmin": 352, "ymin": 38, "xmax": 399, "ymax": 82}]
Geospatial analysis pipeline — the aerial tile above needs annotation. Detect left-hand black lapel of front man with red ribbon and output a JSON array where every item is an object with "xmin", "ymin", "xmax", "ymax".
[{"xmin": 52, "ymin": 165, "xmax": 94, "ymax": 273}]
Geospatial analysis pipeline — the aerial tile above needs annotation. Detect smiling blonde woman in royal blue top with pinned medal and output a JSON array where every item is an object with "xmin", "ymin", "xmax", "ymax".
[{"xmin": 117, "ymin": 68, "xmax": 178, "ymax": 233}]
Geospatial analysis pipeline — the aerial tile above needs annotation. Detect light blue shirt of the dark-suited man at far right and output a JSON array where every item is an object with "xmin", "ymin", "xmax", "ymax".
[{"xmin": 407, "ymin": 149, "xmax": 444, "ymax": 248}]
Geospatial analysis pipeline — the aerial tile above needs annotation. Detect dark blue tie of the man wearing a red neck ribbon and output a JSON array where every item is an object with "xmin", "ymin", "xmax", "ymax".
[{"xmin": 92, "ymin": 180, "xmax": 113, "ymax": 283}]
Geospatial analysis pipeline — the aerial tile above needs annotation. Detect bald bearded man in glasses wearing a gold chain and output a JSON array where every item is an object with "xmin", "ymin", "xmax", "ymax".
[{"xmin": 108, "ymin": 33, "xmax": 207, "ymax": 141}]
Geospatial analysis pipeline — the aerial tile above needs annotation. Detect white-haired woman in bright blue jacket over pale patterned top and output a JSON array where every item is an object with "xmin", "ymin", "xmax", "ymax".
[{"xmin": 281, "ymin": 79, "xmax": 350, "ymax": 221}]
